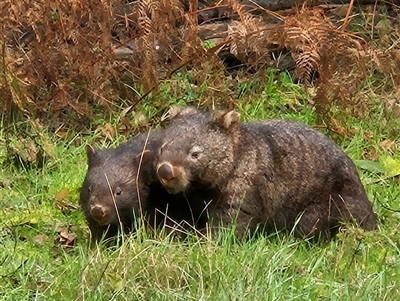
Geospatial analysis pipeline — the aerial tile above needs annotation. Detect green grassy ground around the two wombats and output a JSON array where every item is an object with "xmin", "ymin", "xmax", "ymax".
[{"xmin": 0, "ymin": 71, "xmax": 400, "ymax": 301}]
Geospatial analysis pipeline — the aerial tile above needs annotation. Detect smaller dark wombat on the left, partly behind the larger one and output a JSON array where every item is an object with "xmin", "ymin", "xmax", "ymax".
[{"xmin": 80, "ymin": 131, "xmax": 205, "ymax": 242}]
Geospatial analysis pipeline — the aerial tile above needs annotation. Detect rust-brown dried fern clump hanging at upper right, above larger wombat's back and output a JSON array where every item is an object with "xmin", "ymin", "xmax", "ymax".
[{"xmin": 268, "ymin": 7, "xmax": 376, "ymax": 121}]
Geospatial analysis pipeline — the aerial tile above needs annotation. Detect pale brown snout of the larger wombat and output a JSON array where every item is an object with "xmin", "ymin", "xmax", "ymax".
[{"xmin": 157, "ymin": 161, "xmax": 187, "ymax": 194}]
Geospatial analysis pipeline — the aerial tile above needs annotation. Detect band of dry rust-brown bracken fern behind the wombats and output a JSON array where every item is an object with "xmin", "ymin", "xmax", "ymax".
[{"xmin": 0, "ymin": 0, "xmax": 399, "ymax": 129}]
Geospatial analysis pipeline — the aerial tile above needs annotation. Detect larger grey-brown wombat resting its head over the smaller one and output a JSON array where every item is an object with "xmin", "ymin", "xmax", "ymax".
[{"xmin": 157, "ymin": 107, "xmax": 376, "ymax": 240}]
